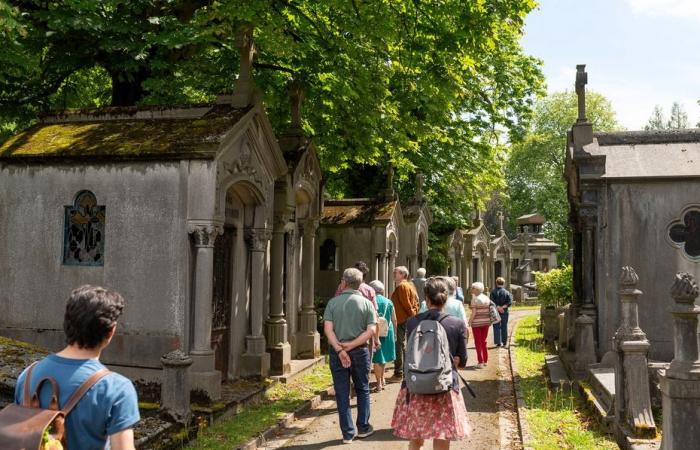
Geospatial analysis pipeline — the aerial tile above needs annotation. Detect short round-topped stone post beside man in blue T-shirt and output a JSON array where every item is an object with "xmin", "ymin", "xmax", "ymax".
[{"xmin": 160, "ymin": 350, "xmax": 192, "ymax": 424}]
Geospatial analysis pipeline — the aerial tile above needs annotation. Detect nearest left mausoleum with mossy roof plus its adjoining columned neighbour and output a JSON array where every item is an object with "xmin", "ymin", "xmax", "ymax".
[{"xmin": 0, "ymin": 35, "xmax": 321, "ymax": 399}]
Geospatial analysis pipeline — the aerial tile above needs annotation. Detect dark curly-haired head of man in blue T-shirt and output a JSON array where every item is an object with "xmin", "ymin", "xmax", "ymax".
[{"xmin": 63, "ymin": 285, "xmax": 124, "ymax": 349}]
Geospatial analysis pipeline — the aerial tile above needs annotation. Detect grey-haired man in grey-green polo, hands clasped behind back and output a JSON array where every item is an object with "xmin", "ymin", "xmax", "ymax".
[{"xmin": 323, "ymin": 268, "xmax": 377, "ymax": 444}]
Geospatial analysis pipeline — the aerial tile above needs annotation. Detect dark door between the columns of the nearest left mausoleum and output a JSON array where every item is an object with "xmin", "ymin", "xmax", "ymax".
[{"xmin": 211, "ymin": 227, "xmax": 235, "ymax": 381}]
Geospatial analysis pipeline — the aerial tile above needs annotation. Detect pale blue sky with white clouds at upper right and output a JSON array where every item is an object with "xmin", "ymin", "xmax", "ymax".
[{"xmin": 522, "ymin": 0, "xmax": 700, "ymax": 130}]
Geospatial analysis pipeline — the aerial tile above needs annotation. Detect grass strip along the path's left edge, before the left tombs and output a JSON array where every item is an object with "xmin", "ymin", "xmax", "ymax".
[{"xmin": 185, "ymin": 365, "xmax": 332, "ymax": 450}]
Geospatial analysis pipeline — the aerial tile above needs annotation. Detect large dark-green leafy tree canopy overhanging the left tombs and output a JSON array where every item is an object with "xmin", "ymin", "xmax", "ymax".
[{"xmin": 0, "ymin": 0, "xmax": 542, "ymax": 224}]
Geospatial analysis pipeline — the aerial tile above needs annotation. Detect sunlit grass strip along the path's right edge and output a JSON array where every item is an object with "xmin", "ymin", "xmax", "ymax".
[{"xmin": 515, "ymin": 316, "xmax": 618, "ymax": 450}]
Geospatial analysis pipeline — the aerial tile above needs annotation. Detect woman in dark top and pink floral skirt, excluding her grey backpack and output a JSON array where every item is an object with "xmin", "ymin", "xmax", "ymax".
[{"xmin": 391, "ymin": 277, "xmax": 470, "ymax": 450}]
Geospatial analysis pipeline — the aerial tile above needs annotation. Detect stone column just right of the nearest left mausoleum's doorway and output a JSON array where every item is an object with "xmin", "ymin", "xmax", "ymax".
[{"xmin": 241, "ymin": 228, "xmax": 270, "ymax": 378}]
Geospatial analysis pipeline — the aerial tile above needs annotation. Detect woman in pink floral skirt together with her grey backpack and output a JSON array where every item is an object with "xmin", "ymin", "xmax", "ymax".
[{"xmin": 391, "ymin": 277, "xmax": 470, "ymax": 450}]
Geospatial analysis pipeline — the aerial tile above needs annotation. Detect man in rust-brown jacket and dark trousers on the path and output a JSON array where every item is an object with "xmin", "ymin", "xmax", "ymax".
[{"xmin": 391, "ymin": 266, "xmax": 419, "ymax": 380}]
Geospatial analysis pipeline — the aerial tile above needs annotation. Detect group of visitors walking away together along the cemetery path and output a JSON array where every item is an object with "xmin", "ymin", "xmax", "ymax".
[{"xmin": 323, "ymin": 262, "xmax": 513, "ymax": 449}]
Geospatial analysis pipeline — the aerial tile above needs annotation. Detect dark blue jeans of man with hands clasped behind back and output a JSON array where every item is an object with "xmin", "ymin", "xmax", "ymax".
[{"xmin": 328, "ymin": 347, "xmax": 370, "ymax": 439}]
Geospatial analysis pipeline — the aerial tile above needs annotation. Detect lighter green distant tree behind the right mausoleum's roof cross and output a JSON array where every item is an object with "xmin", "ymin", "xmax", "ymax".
[{"xmin": 506, "ymin": 91, "xmax": 620, "ymax": 260}]
